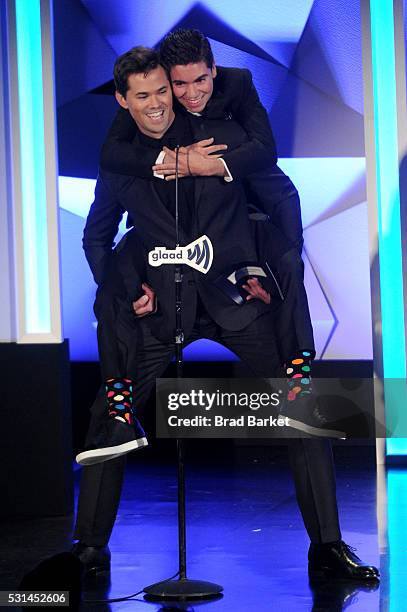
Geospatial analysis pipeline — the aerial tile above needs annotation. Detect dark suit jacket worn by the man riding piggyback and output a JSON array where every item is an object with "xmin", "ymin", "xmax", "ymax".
[{"xmin": 100, "ymin": 66, "xmax": 302, "ymax": 245}]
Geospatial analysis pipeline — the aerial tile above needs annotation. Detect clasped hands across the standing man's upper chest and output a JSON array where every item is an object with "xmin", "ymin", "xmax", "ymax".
[{"xmin": 153, "ymin": 138, "xmax": 227, "ymax": 181}]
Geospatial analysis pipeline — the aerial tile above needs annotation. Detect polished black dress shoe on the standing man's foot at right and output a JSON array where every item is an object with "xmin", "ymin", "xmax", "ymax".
[{"xmin": 308, "ymin": 541, "xmax": 380, "ymax": 581}]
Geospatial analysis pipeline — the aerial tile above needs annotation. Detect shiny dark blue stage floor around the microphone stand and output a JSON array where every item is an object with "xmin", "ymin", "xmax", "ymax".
[{"xmin": 0, "ymin": 444, "xmax": 392, "ymax": 612}]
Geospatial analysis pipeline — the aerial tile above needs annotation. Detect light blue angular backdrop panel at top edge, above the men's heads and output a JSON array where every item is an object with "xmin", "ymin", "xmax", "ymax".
[{"xmin": 82, "ymin": 0, "xmax": 313, "ymax": 66}]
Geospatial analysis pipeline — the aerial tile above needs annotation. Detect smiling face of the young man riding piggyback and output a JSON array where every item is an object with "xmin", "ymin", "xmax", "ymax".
[{"xmin": 171, "ymin": 62, "xmax": 216, "ymax": 113}]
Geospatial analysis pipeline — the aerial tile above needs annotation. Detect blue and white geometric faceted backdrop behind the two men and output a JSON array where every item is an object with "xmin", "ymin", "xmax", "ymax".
[{"xmin": 54, "ymin": 0, "xmax": 372, "ymax": 359}]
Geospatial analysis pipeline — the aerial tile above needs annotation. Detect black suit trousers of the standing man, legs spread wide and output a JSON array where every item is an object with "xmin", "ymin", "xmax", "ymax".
[{"xmin": 74, "ymin": 308, "xmax": 341, "ymax": 546}]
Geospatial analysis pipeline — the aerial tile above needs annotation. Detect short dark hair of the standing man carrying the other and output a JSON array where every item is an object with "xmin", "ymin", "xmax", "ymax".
[{"xmin": 113, "ymin": 47, "xmax": 160, "ymax": 97}]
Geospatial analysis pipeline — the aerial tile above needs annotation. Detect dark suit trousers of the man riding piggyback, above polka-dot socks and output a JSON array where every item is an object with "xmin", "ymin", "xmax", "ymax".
[{"xmin": 94, "ymin": 212, "xmax": 315, "ymax": 379}]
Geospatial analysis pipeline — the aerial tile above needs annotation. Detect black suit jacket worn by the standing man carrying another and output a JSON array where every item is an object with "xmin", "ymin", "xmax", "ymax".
[{"xmin": 83, "ymin": 117, "xmax": 269, "ymax": 340}]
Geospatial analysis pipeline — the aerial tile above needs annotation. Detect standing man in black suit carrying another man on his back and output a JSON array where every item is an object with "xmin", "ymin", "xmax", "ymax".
[{"xmin": 74, "ymin": 48, "xmax": 377, "ymax": 579}]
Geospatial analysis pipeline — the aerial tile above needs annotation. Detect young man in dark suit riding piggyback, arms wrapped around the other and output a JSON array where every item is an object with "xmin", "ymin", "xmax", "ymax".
[{"xmin": 101, "ymin": 30, "xmax": 320, "ymax": 437}]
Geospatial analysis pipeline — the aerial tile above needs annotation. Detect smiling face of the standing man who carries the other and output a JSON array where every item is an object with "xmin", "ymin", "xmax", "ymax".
[{"xmin": 116, "ymin": 66, "xmax": 175, "ymax": 138}]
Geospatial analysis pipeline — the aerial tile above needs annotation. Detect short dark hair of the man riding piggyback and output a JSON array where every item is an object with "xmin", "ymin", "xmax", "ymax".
[{"xmin": 160, "ymin": 29, "xmax": 214, "ymax": 72}]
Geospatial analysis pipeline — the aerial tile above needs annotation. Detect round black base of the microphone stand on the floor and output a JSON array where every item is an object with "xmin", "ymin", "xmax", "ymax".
[{"xmin": 144, "ymin": 578, "xmax": 223, "ymax": 600}]
